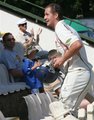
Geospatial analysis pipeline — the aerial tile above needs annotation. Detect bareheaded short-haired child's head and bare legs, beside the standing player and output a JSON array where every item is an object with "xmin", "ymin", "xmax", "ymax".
[{"xmin": 44, "ymin": 49, "xmax": 64, "ymax": 96}]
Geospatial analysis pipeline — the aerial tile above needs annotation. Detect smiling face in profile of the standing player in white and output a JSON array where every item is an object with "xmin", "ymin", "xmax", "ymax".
[{"xmin": 44, "ymin": 7, "xmax": 57, "ymax": 29}]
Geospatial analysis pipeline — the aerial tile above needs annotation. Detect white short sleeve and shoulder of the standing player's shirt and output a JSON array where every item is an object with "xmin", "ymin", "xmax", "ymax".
[{"xmin": 55, "ymin": 23, "xmax": 80, "ymax": 47}]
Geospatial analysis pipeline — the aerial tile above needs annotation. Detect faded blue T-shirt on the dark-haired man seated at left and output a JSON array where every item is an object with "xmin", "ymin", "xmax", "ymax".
[{"xmin": 0, "ymin": 49, "xmax": 23, "ymax": 82}]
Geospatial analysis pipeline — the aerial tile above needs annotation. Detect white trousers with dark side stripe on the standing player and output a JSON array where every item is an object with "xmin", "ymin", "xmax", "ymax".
[{"xmin": 60, "ymin": 70, "xmax": 90, "ymax": 111}]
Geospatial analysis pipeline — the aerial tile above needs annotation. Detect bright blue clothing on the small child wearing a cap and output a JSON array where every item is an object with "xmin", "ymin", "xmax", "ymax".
[{"xmin": 22, "ymin": 58, "xmax": 43, "ymax": 89}]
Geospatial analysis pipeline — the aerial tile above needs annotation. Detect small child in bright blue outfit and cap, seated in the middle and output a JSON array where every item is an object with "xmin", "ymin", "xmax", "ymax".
[{"xmin": 22, "ymin": 49, "xmax": 44, "ymax": 93}]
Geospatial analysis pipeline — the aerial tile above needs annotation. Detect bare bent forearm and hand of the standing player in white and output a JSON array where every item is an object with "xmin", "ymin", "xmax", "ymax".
[{"xmin": 53, "ymin": 40, "xmax": 83, "ymax": 68}]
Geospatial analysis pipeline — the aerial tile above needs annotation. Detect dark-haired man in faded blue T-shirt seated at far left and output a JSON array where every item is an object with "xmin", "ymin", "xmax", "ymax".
[{"xmin": 0, "ymin": 33, "xmax": 24, "ymax": 82}]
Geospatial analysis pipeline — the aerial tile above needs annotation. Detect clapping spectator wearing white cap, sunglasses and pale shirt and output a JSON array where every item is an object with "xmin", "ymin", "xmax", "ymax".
[{"xmin": 16, "ymin": 18, "xmax": 42, "ymax": 55}]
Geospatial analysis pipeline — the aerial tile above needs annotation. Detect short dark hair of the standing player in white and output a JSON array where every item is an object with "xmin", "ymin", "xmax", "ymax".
[{"xmin": 45, "ymin": 3, "xmax": 63, "ymax": 20}]
